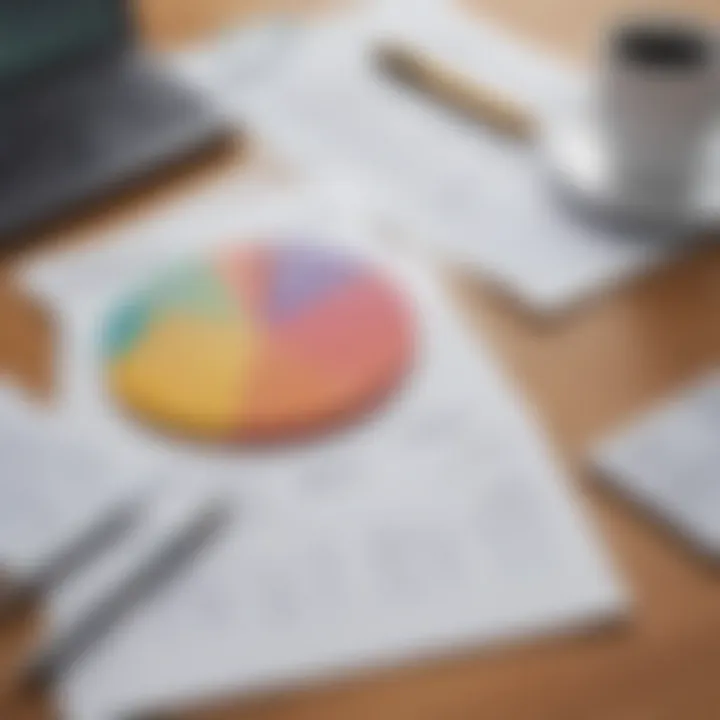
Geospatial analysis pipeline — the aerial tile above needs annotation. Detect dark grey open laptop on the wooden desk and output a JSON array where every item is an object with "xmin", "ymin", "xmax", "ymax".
[{"xmin": 0, "ymin": 0, "xmax": 228, "ymax": 237}]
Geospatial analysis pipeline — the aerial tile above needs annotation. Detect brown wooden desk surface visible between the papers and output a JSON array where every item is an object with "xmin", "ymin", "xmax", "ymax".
[{"xmin": 0, "ymin": 0, "xmax": 720, "ymax": 720}]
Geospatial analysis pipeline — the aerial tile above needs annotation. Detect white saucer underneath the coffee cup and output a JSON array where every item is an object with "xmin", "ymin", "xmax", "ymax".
[{"xmin": 542, "ymin": 116, "xmax": 720, "ymax": 234}]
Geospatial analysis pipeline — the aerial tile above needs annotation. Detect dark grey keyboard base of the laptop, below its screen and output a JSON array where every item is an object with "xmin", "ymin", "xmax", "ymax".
[{"xmin": 0, "ymin": 56, "xmax": 218, "ymax": 231}]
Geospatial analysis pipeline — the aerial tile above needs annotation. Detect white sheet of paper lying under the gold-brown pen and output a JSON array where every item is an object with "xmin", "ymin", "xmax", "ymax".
[{"xmin": 172, "ymin": 0, "xmax": 668, "ymax": 312}]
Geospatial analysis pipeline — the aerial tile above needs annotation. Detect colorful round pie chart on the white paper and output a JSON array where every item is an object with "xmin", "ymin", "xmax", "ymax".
[{"xmin": 103, "ymin": 243, "xmax": 414, "ymax": 441}]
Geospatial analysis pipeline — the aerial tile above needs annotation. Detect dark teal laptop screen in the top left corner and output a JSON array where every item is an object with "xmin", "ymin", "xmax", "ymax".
[{"xmin": 0, "ymin": 0, "xmax": 125, "ymax": 85}]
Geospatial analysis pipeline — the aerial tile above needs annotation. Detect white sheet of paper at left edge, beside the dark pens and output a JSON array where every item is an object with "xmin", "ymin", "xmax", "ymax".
[{"xmin": 0, "ymin": 386, "xmax": 144, "ymax": 587}]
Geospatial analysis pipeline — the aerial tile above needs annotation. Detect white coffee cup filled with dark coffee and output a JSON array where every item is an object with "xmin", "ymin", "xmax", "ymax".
[{"xmin": 600, "ymin": 18, "xmax": 720, "ymax": 216}]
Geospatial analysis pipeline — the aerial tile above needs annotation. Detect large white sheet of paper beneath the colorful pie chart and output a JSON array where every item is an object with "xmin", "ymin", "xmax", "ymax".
[{"xmin": 16, "ymin": 177, "xmax": 625, "ymax": 720}]
